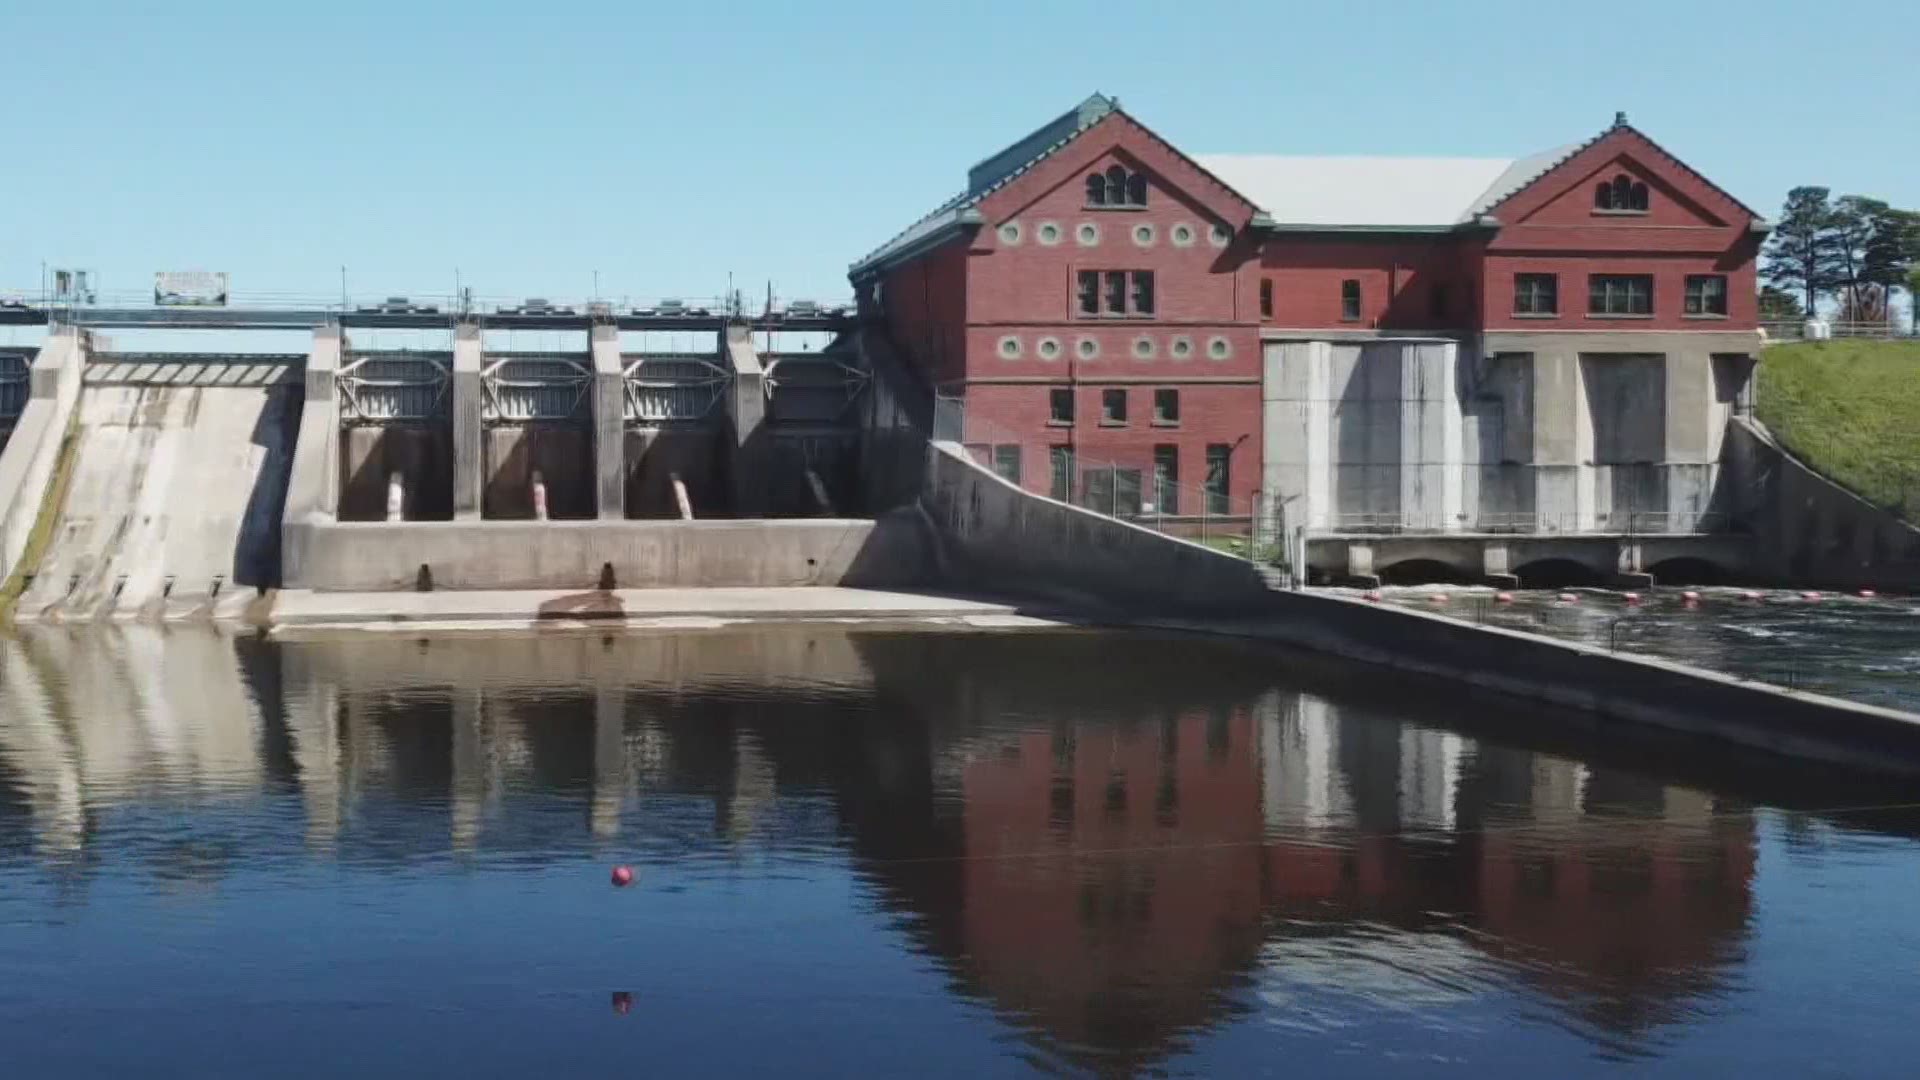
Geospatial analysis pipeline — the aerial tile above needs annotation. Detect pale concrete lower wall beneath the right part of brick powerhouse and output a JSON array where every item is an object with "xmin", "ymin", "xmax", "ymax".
[{"xmin": 1261, "ymin": 332, "xmax": 1757, "ymax": 582}]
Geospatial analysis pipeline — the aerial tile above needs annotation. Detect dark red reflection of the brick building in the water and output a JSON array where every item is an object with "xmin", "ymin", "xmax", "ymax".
[{"xmin": 854, "ymin": 642, "xmax": 1755, "ymax": 1065}]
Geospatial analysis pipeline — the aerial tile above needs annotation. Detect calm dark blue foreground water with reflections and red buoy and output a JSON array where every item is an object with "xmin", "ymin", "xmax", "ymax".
[{"xmin": 0, "ymin": 626, "xmax": 1920, "ymax": 1078}]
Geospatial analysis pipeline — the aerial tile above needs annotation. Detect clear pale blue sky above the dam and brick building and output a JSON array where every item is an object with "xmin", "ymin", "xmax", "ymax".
[{"xmin": 0, "ymin": 0, "xmax": 1920, "ymax": 307}]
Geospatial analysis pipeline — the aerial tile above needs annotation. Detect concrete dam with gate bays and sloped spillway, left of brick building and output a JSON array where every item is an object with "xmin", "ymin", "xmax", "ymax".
[{"xmin": 0, "ymin": 307, "xmax": 927, "ymax": 621}]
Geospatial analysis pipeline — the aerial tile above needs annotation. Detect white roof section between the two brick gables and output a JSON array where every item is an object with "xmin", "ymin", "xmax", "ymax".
[{"xmin": 1198, "ymin": 150, "xmax": 1565, "ymax": 227}]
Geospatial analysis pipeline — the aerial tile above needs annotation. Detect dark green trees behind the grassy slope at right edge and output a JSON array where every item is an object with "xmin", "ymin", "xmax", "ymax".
[{"xmin": 1761, "ymin": 186, "xmax": 1920, "ymax": 323}]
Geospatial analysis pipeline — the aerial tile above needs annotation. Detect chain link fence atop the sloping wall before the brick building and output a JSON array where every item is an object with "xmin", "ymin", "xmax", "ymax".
[{"xmin": 933, "ymin": 396, "xmax": 1290, "ymax": 569}]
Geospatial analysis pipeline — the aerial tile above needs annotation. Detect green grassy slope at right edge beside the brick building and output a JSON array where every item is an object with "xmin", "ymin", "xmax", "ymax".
[{"xmin": 1755, "ymin": 340, "xmax": 1920, "ymax": 521}]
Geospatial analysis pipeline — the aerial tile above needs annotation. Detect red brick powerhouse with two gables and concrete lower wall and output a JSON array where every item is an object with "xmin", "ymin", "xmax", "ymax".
[{"xmin": 851, "ymin": 94, "xmax": 1764, "ymax": 528}]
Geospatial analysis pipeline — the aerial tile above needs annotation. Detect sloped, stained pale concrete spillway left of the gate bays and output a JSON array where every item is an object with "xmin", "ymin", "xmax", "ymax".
[{"xmin": 15, "ymin": 357, "xmax": 301, "ymax": 623}]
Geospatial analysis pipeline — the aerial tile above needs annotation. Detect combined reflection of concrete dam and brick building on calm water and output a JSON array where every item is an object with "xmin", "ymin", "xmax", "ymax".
[{"xmin": 0, "ymin": 626, "xmax": 1789, "ymax": 1067}]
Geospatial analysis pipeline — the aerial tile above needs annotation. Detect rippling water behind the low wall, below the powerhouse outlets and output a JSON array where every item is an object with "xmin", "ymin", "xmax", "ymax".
[{"xmin": 1382, "ymin": 586, "xmax": 1920, "ymax": 711}]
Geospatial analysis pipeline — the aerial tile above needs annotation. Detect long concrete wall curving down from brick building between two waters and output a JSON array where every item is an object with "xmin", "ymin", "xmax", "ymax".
[{"xmin": 922, "ymin": 444, "xmax": 1920, "ymax": 773}]
